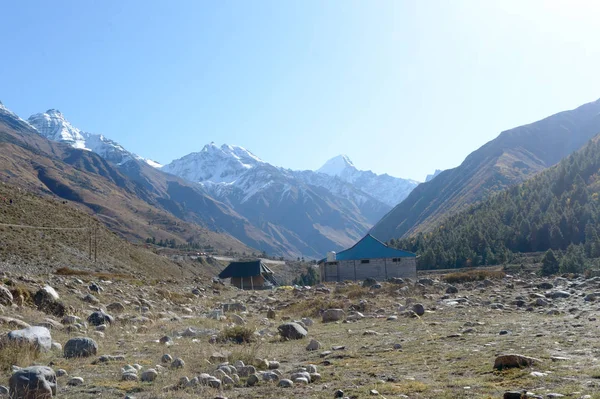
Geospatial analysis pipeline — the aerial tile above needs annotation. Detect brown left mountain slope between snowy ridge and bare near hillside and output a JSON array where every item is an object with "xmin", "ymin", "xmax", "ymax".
[{"xmin": 0, "ymin": 103, "xmax": 251, "ymax": 252}]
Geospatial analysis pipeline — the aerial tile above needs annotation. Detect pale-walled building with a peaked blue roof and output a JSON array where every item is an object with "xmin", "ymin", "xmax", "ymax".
[{"xmin": 319, "ymin": 234, "xmax": 417, "ymax": 282}]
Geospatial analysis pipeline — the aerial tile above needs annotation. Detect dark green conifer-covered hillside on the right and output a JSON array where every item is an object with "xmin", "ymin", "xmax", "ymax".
[{"xmin": 390, "ymin": 136, "xmax": 600, "ymax": 269}]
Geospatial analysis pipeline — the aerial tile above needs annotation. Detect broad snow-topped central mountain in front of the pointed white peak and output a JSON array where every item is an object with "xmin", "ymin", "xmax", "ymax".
[{"xmin": 161, "ymin": 143, "xmax": 390, "ymax": 258}]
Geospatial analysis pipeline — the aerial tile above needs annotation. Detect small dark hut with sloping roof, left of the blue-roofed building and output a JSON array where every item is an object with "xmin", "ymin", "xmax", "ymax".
[{"xmin": 219, "ymin": 260, "xmax": 276, "ymax": 290}]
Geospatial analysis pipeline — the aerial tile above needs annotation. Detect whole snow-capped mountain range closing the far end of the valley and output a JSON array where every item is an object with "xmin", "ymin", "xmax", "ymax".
[{"xmin": 12, "ymin": 103, "xmax": 418, "ymax": 258}]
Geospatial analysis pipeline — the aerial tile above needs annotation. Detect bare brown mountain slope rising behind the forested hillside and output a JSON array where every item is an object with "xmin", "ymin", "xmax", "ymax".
[{"xmin": 371, "ymin": 100, "xmax": 600, "ymax": 245}]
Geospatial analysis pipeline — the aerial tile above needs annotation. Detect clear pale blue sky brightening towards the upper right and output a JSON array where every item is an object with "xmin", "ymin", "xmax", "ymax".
[{"xmin": 0, "ymin": 0, "xmax": 600, "ymax": 180}]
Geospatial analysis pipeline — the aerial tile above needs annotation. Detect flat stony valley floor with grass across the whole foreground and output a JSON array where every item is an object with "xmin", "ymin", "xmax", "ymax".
[{"xmin": 0, "ymin": 274, "xmax": 600, "ymax": 399}]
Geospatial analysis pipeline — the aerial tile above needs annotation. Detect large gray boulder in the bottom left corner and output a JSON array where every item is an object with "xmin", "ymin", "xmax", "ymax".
[{"xmin": 8, "ymin": 366, "xmax": 56, "ymax": 399}]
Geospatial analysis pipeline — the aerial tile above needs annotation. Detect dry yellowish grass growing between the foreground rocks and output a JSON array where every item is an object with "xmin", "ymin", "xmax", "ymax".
[{"xmin": 0, "ymin": 270, "xmax": 600, "ymax": 399}]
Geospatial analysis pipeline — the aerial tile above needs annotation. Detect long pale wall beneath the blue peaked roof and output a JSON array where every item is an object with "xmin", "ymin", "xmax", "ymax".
[{"xmin": 321, "ymin": 257, "xmax": 417, "ymax": 281}]
